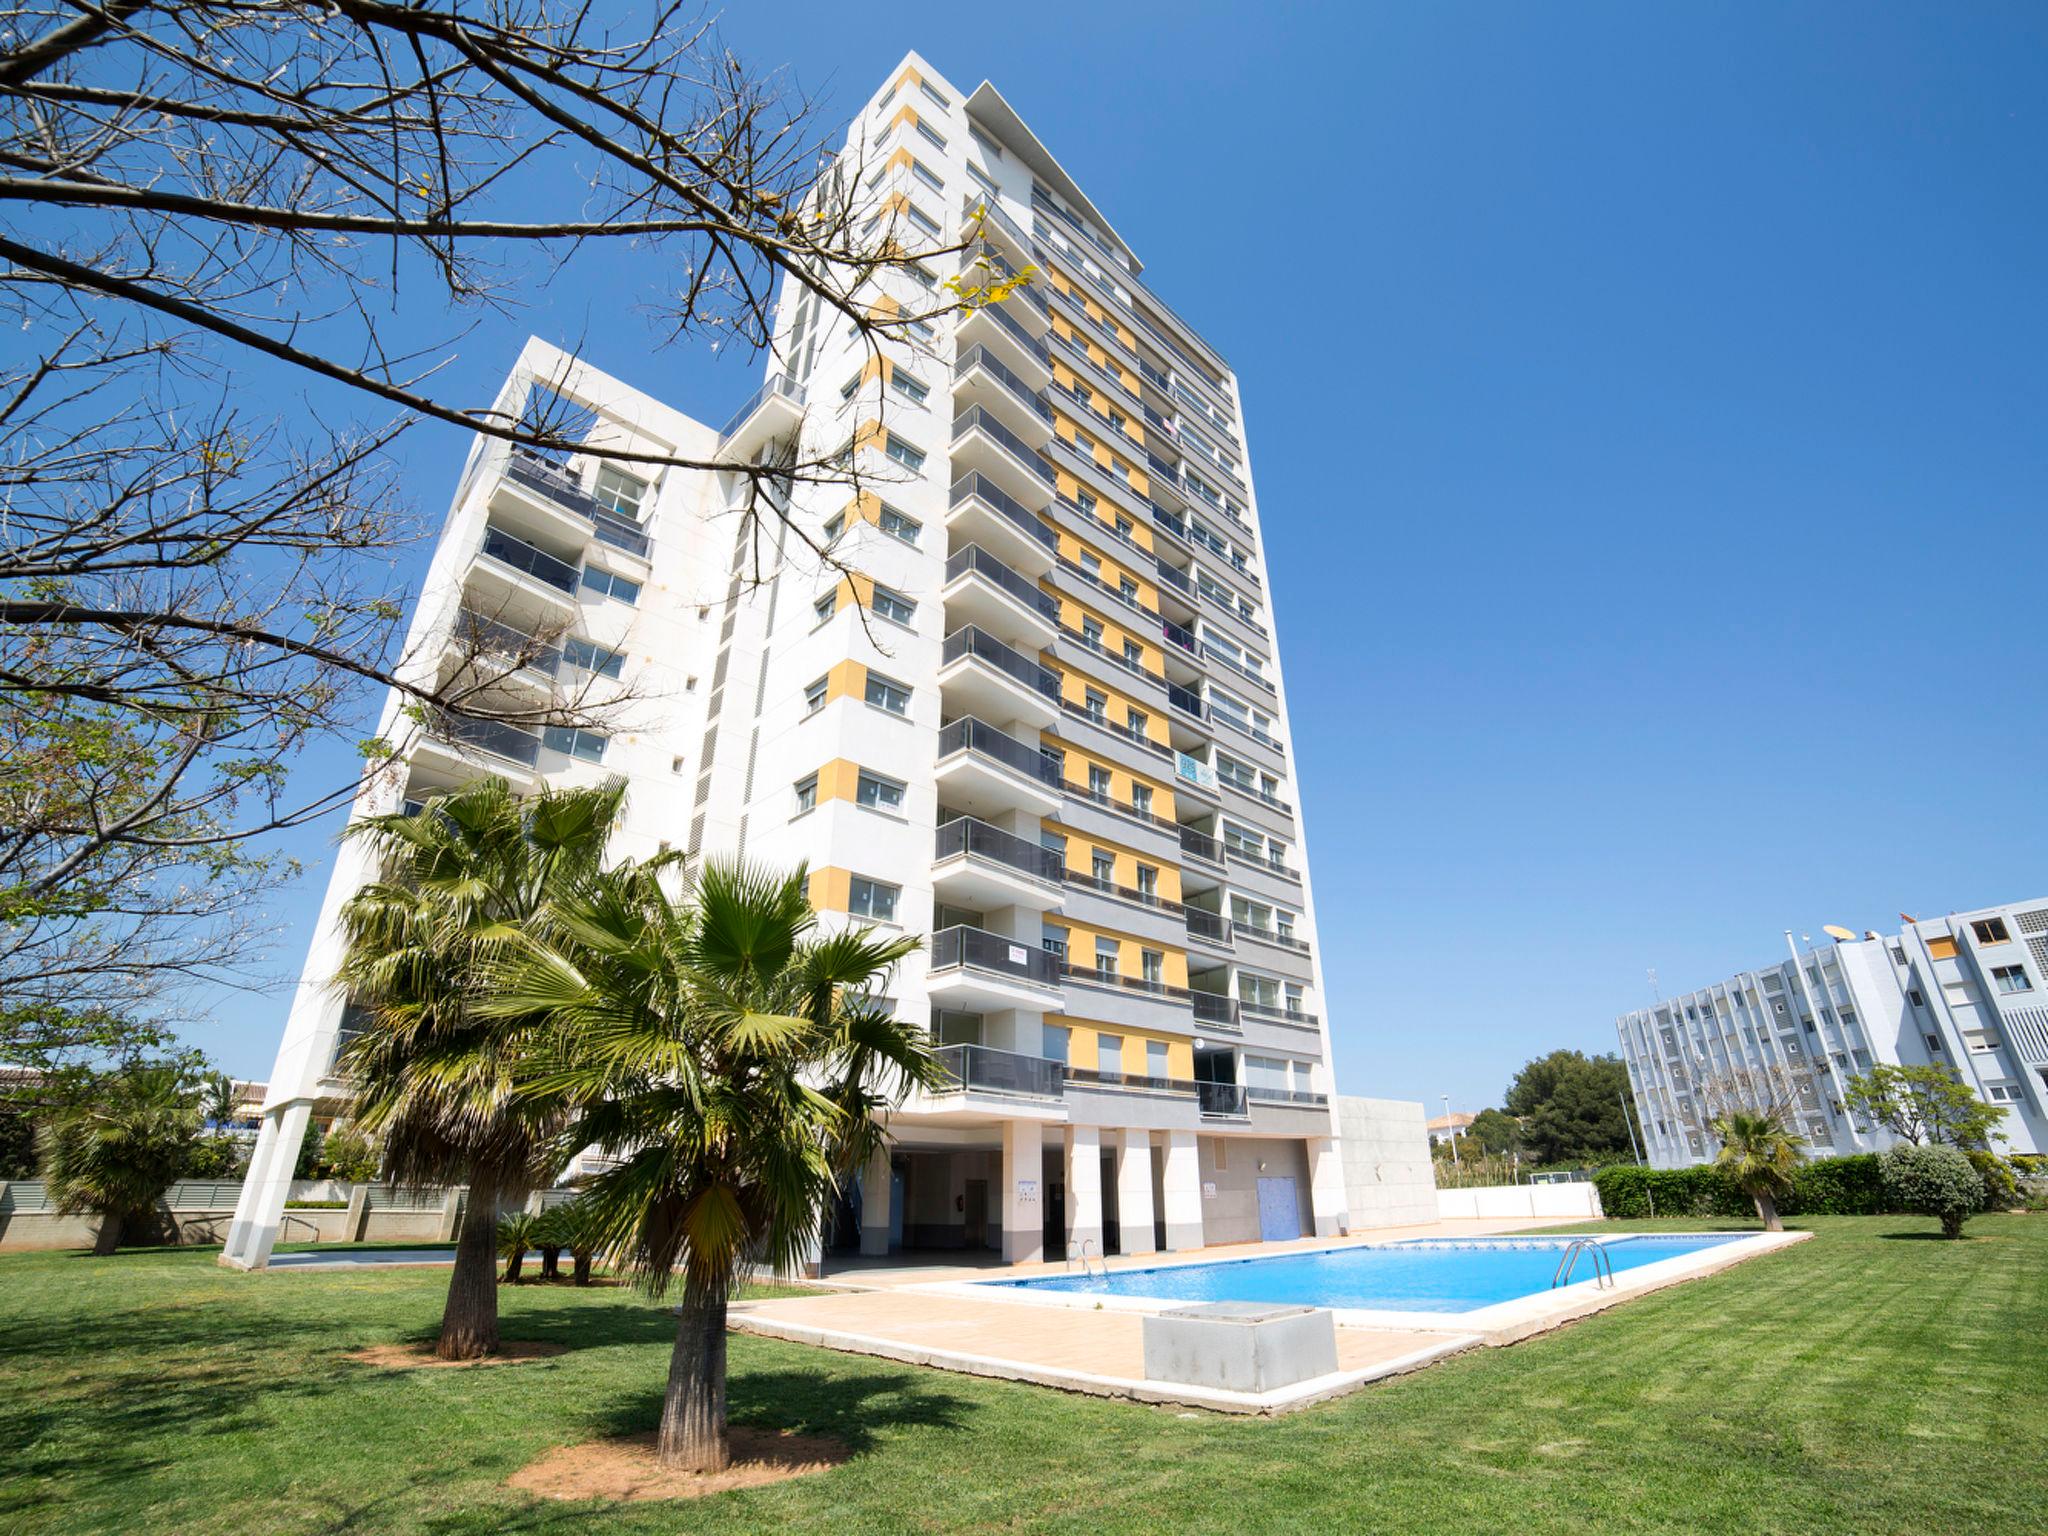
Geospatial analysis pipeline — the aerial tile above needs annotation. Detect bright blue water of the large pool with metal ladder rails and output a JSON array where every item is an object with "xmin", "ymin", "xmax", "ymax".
[{"xmin": 985, "ymin": 1233, "xmax": 1747, "ymax": 1313}]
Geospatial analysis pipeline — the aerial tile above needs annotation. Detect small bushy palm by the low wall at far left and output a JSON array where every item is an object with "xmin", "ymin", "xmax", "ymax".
[{"xmin": 37, "ymin": 1065, "xmax": 199, "ymax": 1255}]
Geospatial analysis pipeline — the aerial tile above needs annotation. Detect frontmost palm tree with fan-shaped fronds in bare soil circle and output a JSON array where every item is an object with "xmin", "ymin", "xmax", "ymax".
[{"xmin": 487, "ymin": 862, "xmax": 938, "ymax": 1470}]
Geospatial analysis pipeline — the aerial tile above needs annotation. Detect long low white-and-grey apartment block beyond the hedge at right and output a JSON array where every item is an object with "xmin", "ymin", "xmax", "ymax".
[{"xmin": 1616, "ymin": 899, "xmax": 2048, "ymax": 1167}]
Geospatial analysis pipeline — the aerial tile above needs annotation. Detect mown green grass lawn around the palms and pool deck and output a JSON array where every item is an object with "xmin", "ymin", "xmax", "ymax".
[{"xmin": 0, "ymin": 1217, "xmax": 2048, "ymax": 1536}]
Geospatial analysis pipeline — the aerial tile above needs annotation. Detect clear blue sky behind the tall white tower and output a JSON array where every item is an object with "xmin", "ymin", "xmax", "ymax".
[{"xmin": 172, "ymin": 0, "xmax": 2048, "ymax": 1108}]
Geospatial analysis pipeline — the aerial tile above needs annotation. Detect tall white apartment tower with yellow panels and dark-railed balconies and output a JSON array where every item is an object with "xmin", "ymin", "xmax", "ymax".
[{"xmin": 227, "ymin": 55, "xmax": 1348, "ymax": 1264}]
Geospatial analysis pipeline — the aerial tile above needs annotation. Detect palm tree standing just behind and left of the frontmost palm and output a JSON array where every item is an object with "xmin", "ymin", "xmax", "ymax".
[{"xmin": 336, "ymin": 778, "xmax": 625, "ymax": 1360}]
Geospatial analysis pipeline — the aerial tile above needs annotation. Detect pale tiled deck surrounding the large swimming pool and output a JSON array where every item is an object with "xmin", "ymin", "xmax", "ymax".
[{"xmin": 731, "ymin": 1221, "xmax": 1806, "ymax": 1413}]
